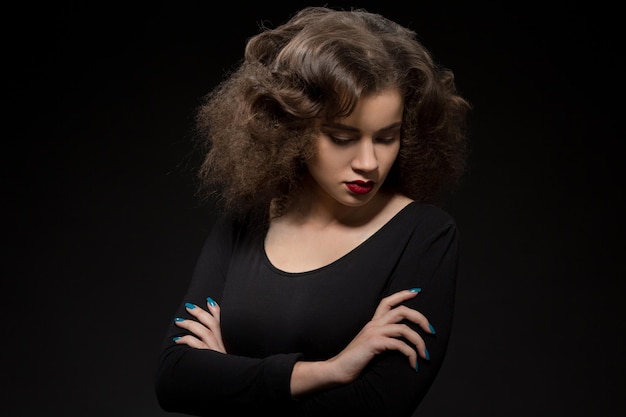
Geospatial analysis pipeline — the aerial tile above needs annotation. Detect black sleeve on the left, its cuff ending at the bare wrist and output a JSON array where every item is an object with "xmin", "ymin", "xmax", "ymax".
[{"xmin": 155, "ymin": 216, "xmax": 299, "ymax": 416}]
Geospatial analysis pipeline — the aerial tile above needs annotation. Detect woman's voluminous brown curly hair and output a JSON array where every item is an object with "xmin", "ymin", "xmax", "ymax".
[{"xmin": 195, "ymin": 7, "xmax": 471, "ymax": 224}]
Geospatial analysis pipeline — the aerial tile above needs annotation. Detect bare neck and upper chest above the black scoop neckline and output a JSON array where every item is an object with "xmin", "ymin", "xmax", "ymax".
[{"xmin": 265, "ymin": 195, "xmax": 412, "ymax": 272}]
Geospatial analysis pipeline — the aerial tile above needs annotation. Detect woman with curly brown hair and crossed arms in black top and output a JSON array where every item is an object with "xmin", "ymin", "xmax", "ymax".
[{"xmin": 156, "ymin": 7, "xmax": 470, "ymax": 417}]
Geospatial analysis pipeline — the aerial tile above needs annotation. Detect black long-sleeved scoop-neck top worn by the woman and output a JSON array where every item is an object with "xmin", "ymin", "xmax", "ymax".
[{"xmin": 156, "ymin": 202, "xmax": 458, "ymax": 417}]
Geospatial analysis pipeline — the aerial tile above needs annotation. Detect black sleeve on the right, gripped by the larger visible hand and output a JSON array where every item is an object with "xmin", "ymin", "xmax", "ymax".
[{"xmin": 292, "ymin": 210, "xmax": 459, "ymax": 417}]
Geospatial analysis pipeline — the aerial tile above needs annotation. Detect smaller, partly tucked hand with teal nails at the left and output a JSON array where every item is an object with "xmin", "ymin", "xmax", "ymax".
[{"xmin": 175, "ymin": 297, "xmax": 226, "ymax": 353}]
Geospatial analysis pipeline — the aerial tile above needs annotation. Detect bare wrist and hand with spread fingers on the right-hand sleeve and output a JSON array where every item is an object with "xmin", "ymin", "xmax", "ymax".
[{"xmin": 291, "ymin": 288, "xmax": 433, "ymax": 396}]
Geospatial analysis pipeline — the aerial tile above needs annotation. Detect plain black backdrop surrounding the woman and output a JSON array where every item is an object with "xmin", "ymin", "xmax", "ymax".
[{"xmin": 6, "ymin": 1, "xmax": 626, "ymax": 417}]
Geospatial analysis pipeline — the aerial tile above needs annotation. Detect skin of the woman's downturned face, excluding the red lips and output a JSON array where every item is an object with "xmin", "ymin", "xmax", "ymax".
[{"xmin": 308, "ymin": 89, "xmax": 403, "ymax": 211}]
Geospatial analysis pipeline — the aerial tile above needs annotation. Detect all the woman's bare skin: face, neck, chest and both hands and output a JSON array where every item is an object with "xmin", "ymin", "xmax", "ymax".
[{"xmin": 176, "ymin": 89, "xmax": 431, "ymax": 397}]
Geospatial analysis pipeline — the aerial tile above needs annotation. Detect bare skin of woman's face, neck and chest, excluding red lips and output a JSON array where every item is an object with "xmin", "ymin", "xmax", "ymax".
[{"xmin": 265, "ymin": 89, "xmax": 411, "ymax": 272}]
